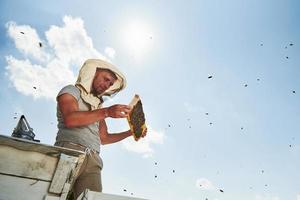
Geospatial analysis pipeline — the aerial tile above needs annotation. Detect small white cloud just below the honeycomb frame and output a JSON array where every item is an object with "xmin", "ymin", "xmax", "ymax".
[{"xmin": 122, "ymin": 127, "xmax": 165, "ymax": 157}]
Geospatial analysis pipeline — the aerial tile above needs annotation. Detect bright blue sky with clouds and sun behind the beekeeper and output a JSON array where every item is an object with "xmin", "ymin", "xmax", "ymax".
[{"xmin": 0, "ymin": 0, "xmax": 300, "ymax": 200}]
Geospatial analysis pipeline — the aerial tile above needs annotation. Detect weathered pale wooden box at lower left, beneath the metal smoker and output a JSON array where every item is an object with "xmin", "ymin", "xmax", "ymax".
[{"xmin": 0, "ymin": 135, "xmax": 85, "ymax": 200}]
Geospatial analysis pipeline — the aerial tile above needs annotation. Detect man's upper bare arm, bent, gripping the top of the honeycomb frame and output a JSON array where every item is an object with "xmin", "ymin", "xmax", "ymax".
[{"xmin": 57, "ymin": 94, "xmax": 130, "ymax": 128}]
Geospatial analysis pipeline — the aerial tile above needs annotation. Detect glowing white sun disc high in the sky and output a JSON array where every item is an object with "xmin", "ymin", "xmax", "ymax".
[{"xmin": 123, "ymin": 21, "xmax": 153, "ymax": 57}]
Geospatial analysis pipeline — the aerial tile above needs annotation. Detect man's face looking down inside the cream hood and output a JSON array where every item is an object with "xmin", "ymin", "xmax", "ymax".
[{"xmin": 92, "ymin": 70, "xmax": 116, "ymax": 95}]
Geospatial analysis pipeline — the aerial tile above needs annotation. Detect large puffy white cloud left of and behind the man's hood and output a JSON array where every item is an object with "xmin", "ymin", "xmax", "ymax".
[{"xmin": 6, "ymin": 16, "xmax": 107, "ymax": 99}]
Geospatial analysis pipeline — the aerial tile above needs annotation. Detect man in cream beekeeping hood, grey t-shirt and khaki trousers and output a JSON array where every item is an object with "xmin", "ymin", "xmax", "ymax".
[{"xmin": 55, "ymin": 59, "xmax": 146, "ymax": 199}]
